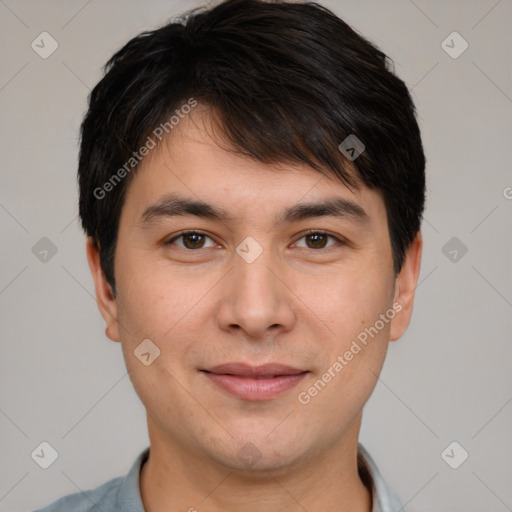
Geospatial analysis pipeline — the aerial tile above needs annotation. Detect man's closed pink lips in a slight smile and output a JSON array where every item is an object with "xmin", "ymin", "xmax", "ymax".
[{"xmin": 201, "ymin": 363, "xmax": 309, "ymax": 401}]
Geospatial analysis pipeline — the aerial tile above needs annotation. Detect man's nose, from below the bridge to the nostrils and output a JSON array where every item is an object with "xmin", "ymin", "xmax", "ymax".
[{"xmin": 218, "ymin": 243, "xmax": 296, "ymax": 340}]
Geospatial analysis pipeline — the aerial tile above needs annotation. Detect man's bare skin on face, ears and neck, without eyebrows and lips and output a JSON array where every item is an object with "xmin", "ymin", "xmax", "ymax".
[{"xmin": 87, "ymin": 108, "xmax": 422, "ymax": 512}]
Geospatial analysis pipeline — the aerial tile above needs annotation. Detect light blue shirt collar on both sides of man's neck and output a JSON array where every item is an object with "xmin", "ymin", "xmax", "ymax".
[{"xmin": 117, "ymin": 443, "xmax": 402, "ymax": 512}]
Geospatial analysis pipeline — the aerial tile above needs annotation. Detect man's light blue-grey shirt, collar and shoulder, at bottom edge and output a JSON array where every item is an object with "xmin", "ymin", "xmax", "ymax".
[{"xmin": 34, "ymin": 443, "xmax": 402, "ymax": 512}]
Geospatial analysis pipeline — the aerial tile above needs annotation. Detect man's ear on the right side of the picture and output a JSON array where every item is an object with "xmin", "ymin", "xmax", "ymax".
[{"xmin": 389, "ymin": 233, "xmax": 423, "ymax": 341}]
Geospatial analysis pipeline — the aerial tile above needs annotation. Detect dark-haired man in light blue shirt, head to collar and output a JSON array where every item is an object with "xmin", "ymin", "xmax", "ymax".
[{"xmin": 33, "ymin": 0, "xmax": 425, "ymax": 512}]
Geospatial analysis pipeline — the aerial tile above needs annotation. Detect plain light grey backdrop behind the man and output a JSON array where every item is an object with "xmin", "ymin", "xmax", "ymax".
[{"xmin": 0, "ymin": 0, "xmax": 512, "ymax": 512}]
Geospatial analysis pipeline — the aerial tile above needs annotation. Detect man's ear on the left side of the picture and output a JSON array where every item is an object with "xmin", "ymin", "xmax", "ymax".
[{"xmin": 86, "ymin": 236, "xmax": 121, "ymax": 341}]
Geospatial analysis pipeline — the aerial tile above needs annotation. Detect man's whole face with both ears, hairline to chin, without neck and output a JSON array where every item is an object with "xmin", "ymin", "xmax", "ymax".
[{"xmin": 88, "ymin": 107, "xmax": 421, "ymax": 470}]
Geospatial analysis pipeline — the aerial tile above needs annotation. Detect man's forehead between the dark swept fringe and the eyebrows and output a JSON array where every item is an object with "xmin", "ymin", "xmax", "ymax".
[{"xmin": 119, "ymin": 111, "xmax": 386, "ymax": 229}]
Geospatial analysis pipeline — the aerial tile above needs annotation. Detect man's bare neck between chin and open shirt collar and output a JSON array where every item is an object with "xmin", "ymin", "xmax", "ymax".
[{"xmin": 140, "ymin": 417, "xmax": 372, "ymax": 512}]
